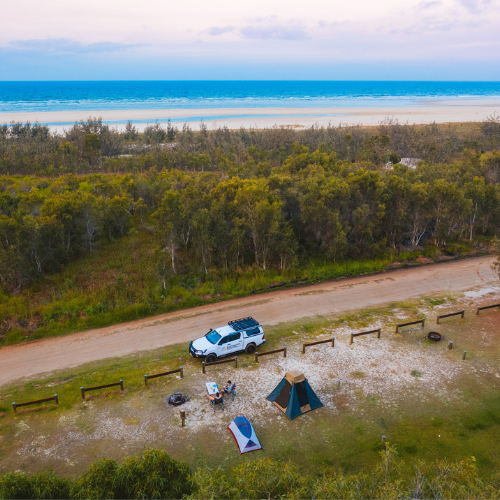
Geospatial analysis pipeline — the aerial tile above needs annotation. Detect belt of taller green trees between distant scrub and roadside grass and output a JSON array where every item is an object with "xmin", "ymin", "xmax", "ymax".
[{"xmin": 0, "ymin": 142, "xmax": 500, "ymax": 291}]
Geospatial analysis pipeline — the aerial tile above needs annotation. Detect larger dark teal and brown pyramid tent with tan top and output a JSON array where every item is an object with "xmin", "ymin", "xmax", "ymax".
[{"xmin": 267, "ymin": 371, "xmax": 323, "ymax": 420}]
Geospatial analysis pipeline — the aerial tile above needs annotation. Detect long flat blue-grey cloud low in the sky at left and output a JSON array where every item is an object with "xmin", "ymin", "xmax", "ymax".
[{"xmin": 9, "ymin": 38, "xmax": 144, "ymax": 54}]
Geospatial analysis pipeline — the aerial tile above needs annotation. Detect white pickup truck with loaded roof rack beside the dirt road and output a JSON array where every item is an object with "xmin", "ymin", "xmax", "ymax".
[{"xmin": 189, "ymin": 317, "xmax": 266, "ymax": 363}]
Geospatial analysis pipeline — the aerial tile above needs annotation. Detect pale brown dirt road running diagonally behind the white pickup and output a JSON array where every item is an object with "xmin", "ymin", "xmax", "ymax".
[{"xmin": 0, "ymin": 256, "xmax": 499, "ymax": 385}]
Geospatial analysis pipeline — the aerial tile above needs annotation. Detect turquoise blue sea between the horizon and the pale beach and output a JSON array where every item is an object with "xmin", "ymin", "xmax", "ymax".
[{"xmin": 0, "ymin": 81, "xmax": 500, "ymax": 114}]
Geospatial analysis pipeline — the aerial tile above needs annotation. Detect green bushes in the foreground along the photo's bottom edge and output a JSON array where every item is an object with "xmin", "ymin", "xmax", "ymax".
[{"xmin": 0, "ymin": 445, "xmax": 500, "ymax": 500}]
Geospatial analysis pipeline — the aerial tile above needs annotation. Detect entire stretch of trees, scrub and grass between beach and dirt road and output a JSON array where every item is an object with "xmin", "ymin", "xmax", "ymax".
[{"xmin": 0, "ymin": 117, "xmax": 500, "ymax": 345}]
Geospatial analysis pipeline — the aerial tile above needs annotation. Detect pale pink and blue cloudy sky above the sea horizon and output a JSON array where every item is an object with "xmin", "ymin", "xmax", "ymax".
[{"xmin": 0, "ymin": 0, "xmax": 500, "ymax": 81}]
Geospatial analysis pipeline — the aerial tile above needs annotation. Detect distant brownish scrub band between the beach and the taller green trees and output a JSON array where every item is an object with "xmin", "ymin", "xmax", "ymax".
[{"xmin": 0, "ymin": 115, "xmax": 500, "ymax": 177}]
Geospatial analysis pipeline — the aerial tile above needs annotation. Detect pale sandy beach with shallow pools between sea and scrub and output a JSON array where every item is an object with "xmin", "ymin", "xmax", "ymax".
[{"xmin": 0, "ymin": 99, "xmax": 500, "ymax": 131}]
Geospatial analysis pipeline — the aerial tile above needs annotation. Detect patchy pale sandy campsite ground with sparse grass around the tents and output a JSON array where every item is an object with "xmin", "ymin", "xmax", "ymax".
[{"xmin": 0, "ymin": 286, "xmax": 500, "ymax": 474}]
